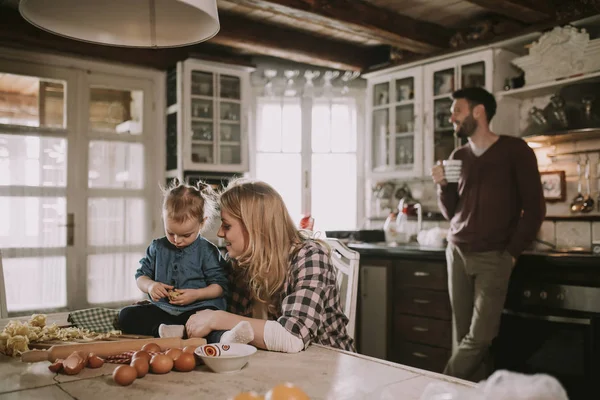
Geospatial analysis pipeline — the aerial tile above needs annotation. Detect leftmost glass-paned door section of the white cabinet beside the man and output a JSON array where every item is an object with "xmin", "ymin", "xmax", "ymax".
[{"xmin": 368, "ymin": 68, "xmax": 423, "ymax": 177}]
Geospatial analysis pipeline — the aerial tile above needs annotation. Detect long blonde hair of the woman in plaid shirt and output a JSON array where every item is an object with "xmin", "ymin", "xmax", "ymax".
[{"xmin": 219, "ymin": 179, "xmax": 304, "ymax": 306}]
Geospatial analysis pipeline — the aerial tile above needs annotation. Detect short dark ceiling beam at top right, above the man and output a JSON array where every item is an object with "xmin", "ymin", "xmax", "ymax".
[{"xmin": 467, "ymin": 0, "xmax": 555, "ymax": 23}]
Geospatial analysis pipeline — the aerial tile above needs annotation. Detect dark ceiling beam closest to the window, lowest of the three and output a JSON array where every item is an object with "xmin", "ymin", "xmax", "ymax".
[{"xmin": 209, "ymin": 12, "xmax": 389, "ymax": 71}]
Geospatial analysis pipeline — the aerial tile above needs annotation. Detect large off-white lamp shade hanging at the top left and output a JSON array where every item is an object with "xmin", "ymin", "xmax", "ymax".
[{"xmin": 19, "ymin": 0, "xmax": 219, "ymax": 48}]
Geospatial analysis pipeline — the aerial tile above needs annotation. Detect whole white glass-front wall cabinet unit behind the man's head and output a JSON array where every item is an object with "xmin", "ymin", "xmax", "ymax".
[{"xmin": 365, "ymin": 49, "xmax": 519, "ymax": 180}]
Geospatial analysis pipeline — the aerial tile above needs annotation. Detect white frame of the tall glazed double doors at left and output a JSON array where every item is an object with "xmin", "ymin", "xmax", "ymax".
[{"xmin": 0, "ymin": 47, "xmax": 166, "ymax": 316}]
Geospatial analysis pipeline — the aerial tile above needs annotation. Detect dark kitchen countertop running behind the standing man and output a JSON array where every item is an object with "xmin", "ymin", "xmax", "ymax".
[{"xmin": 347, "ymin": 243, "xmax": 600, "ymax": 267}]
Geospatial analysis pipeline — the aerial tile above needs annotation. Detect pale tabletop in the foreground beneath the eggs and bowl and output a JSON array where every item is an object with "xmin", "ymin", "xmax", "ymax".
[{"xmin": 0, "ymin": 345, "xmax": 474, "ymax": 400}]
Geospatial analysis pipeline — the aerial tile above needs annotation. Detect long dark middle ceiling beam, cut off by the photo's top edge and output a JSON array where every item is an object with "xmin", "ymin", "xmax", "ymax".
[{"xmin": 227, "ymin": 0, "xmax": 455, "ymax": 54}]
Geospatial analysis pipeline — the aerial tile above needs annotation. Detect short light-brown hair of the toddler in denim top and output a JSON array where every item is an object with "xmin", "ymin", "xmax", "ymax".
[{"xmin": 162, "ymin": 179, "xmax": 217, "ymax": 231}]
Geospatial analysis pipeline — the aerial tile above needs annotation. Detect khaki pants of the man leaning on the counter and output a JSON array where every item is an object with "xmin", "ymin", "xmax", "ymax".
[{"xmin": 444, "ymin": 244, "xmax": 513, "ymax": 381}]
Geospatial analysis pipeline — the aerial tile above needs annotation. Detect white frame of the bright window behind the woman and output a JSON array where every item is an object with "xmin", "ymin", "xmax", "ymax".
[{"xmin": 250, "ymin": 88, "xmax": 368, "ymax": 229}]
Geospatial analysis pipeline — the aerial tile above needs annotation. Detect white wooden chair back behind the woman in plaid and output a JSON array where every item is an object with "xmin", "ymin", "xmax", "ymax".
[{"xmin": 324, "ymin": 238, "xmax": 360, "ymax": 338}]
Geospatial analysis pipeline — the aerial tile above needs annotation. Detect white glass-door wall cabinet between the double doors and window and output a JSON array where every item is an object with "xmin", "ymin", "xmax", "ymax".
[{"xmin": 167, "ymin": 59, "xmax": 253, "ymax": 178}]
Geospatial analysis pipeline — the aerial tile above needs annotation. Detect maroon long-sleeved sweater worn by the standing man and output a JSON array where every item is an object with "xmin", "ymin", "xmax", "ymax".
[{"xmin": 438, "ymin": 136, "xmax": 546, "ymax": 258}]
